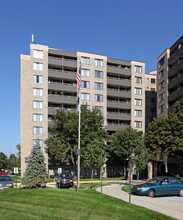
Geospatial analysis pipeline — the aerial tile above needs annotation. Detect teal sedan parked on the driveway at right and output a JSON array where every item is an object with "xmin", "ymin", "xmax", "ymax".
[{"xmin": 131, "ymin": 176, "xmax": 183, "ymax": 197}]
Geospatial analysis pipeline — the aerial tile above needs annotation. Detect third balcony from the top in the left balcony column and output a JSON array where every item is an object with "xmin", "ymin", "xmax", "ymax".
[{"xmin": 48, "ymin": 82, "xmax": 77, "ymax": 92}]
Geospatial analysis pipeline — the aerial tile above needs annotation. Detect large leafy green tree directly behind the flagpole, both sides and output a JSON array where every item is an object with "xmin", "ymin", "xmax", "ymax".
[{"xmin": 45, "ymin": 105, "xmax": 107, "ymax": 167}]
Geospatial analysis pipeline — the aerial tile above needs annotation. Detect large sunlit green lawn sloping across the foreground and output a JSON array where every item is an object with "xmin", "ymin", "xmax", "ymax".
[{"xmin": 0, "ymin": 188, "xmax": 172, "ymax": 220}]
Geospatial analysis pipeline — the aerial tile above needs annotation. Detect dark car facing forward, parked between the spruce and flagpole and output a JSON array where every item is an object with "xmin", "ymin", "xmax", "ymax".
[{"xmin": 56, "ymin": 173, "xmax": 74, "ymax": 188}]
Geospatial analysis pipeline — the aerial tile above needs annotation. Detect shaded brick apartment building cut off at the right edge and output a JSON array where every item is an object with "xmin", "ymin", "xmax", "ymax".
[{"xmin": 157, "ymin": 36, "xmax": 183, "ymax": 117}]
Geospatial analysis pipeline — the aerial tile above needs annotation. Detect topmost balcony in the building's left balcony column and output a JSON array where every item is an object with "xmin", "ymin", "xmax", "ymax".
[{"xmin": 48, "ymin": 57, "xmax": 77, "ymax": 68}]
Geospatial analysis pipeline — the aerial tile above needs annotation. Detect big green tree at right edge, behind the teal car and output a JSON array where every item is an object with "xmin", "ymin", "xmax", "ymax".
[{"xmin": 145, "ymin": 99, "xmax": 183, "ymax": 172}]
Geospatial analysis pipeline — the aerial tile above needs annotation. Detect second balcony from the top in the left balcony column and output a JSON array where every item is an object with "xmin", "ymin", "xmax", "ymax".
[{"xmin": 48, "ymin": 69, "xmax": 76, "ymax": 80}]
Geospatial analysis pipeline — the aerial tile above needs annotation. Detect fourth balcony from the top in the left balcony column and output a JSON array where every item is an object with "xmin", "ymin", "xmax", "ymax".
[{"xmin": 48, "ymin": 94, "xmax": 76, "ymax": 105}]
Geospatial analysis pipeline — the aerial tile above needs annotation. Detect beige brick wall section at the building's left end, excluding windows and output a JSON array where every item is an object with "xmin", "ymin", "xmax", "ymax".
[{"xmin": 21, "ymin": 44, "xmax": 48, "ymax": 175}]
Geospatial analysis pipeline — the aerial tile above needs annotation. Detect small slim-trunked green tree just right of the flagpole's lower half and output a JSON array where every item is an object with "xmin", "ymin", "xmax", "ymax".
[{"xmin": 83, "ymin": 139, "xmax": 106, "ymax": 181}]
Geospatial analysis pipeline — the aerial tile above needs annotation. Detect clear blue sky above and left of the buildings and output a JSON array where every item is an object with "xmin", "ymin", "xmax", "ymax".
[{"xmin": 0, "ymin": 0, "xmax": 183, "ymax": 156}]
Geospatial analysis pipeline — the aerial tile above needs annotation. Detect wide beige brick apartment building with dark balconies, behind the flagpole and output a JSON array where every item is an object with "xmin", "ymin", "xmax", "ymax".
[{"xmin": 21, "ymin": 44, "xmax": 147, "ymax": 177}]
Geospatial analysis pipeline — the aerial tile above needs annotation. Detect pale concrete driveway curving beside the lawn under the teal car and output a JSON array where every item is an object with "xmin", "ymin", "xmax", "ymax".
[{"xmin": 97, "ymin": 184, "xmax": 183, "ymax": 220}]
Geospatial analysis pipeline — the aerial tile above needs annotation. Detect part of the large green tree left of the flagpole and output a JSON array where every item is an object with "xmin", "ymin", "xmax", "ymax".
[{"xmin": 45, "ymin": 110, "xmax": 78, "ymax": 166}]
